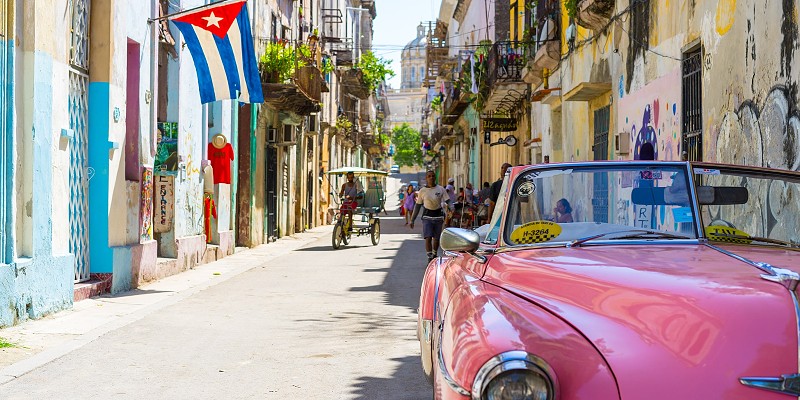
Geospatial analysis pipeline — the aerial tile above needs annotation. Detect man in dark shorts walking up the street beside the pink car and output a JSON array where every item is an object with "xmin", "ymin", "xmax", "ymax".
[{"xmin": 411, "ymin": 171, "xmax": 450, "ymax": 262}]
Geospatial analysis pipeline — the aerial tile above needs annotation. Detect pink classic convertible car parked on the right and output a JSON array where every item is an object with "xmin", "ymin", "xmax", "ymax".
[{"xmin": 418, "ymin": 161, "xmax": 800, "ymax": 400}]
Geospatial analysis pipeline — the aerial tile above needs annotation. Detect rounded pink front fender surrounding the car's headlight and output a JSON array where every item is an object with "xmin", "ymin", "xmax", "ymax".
[{"xmin": 434, "ymin": 280, "xmax": 619, "ymax": 400}]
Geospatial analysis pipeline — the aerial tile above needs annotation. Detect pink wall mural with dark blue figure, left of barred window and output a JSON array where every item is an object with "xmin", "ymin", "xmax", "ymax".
[{"xmin": 617, "ymin": 68, "xmax": 681, "ymax": 160}]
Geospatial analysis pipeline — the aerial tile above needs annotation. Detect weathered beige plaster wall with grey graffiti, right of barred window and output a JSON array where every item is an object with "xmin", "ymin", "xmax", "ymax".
[{"xmin": 694, "ymin": 0, "xmax": 800, "ymax": 170}]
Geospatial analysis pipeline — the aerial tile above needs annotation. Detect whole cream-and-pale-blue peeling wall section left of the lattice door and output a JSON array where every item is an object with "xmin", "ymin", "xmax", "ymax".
[{"xmin": 0, "ymin": 1, "xmax": 74, "ymax": 327}]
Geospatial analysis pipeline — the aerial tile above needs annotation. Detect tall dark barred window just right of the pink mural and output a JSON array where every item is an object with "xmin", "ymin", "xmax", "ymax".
[{"xmin": 681, "ymin": 47, "xmax": 703, "ymax": 161}]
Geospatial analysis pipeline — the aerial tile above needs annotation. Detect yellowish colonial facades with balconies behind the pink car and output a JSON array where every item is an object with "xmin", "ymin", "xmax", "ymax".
[{"xmin": 428, "ymin": 0, "xmax": 800, "ymax": 215}]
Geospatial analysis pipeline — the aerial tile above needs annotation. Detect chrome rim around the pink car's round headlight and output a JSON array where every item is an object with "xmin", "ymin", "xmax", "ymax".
[{"xmin": 472, "ymin": 350, "xmax": 558, "ymax": 400}]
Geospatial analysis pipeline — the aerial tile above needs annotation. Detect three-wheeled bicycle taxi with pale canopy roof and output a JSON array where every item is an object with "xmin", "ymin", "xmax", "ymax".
[{"xmin": 328, "ymin": 167, "xmax": 388, "ymax": 249}]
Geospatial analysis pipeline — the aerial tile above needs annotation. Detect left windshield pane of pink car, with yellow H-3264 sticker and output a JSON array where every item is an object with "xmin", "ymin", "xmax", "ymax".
[{"xmin": 504, "ymin": 164, "xmax": 697, "ymax": 245}]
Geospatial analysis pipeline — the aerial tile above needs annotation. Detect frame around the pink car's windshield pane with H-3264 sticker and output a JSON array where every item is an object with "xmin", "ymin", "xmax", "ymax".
[{"xmin": 504, "ymin": 161, "xmax": 705, "ymax": 248}]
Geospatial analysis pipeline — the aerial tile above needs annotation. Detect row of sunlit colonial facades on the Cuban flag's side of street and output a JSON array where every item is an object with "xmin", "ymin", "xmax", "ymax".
[{"xmin": 0, "ymin": 0, "xmax": 388, "ymax": 327}]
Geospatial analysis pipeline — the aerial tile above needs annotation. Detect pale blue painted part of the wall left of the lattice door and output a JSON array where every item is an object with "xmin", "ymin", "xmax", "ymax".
[{"xmin": 0, "ymin": 52, "xmax": 74, "ymax": 327}]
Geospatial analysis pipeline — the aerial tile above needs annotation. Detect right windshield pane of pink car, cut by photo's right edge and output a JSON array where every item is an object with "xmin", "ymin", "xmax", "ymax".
[{"xmin": 693, "ymin": 167, "xmax": 800, "ymax": 247}]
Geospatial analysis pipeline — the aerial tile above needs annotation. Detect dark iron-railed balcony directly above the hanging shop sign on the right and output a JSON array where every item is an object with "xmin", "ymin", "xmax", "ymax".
[{"xmin": 484, "ymin": 41, "xmax": 531, "ymax": 113}]
